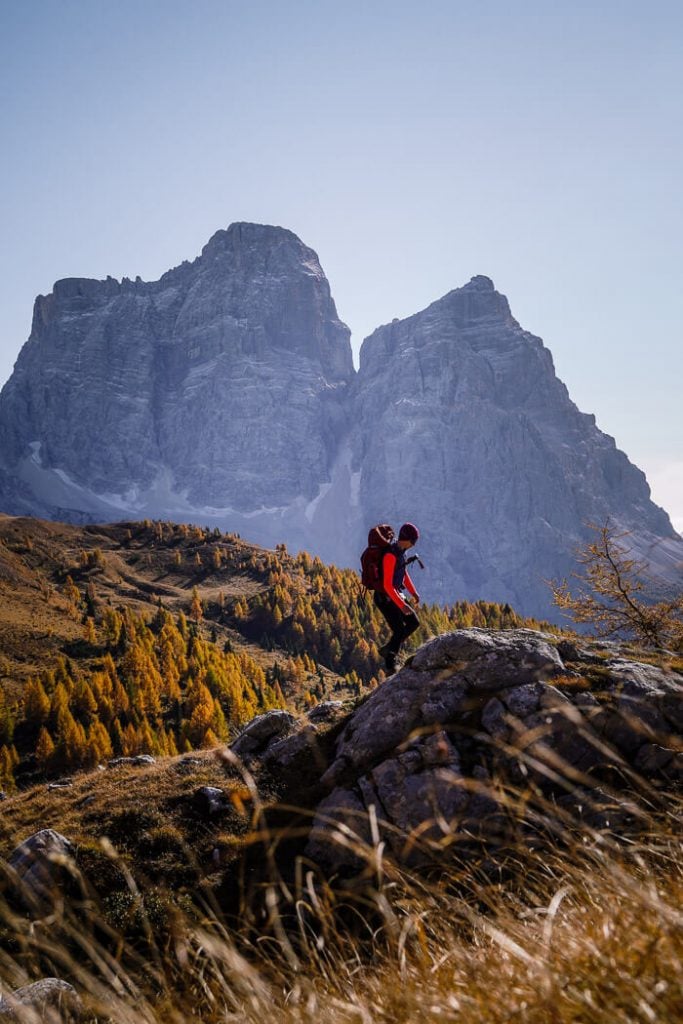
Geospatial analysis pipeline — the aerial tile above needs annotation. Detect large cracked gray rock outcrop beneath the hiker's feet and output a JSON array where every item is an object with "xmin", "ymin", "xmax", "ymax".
[{"xmin": 306, "ymin": 629, "xmax": 683, "ymax": 872}]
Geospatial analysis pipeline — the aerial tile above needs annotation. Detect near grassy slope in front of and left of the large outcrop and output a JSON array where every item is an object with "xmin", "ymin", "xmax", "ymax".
[{"xmin": 0, "ymin": 716, "xmax": 683, "ymax": 1024}]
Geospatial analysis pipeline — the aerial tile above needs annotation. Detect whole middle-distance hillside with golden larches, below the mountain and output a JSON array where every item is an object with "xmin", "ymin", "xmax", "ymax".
[{"xmin": 0, "ymin": 516, "xmax": 557, "ymax": 792}]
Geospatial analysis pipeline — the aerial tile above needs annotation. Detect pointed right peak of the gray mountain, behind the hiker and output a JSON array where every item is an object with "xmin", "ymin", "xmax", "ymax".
[{"xmin": 353, "ymin": 276, "xmax": 683, "ymax": 613}]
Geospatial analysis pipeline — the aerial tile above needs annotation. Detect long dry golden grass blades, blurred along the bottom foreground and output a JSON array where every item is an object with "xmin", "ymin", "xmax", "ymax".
[{"xmin": 0, "ymin": 769, "xmax": 683, "ymax": 1024}]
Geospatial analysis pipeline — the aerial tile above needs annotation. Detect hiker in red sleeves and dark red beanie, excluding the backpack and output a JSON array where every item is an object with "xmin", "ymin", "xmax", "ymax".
[{"xmin": 374, "ymin": 522, "xmax": 420, "ymax": 675}]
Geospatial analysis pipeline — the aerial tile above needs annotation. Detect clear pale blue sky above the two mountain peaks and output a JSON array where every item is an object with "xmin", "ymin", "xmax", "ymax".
[{"xmin": 0, "ymin": 0, "xmax": 683, "ymax": 529}]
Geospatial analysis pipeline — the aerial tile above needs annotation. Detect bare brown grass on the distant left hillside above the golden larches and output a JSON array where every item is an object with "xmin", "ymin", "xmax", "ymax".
[{"xmin": 0, "ymin": 514, "xmax": 280, "ymax": 698}]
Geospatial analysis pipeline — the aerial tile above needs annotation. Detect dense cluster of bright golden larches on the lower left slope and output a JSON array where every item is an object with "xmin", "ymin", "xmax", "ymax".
[{"xmin": 0, "ymin": 608, "xmax": 286, "ymax": 790}]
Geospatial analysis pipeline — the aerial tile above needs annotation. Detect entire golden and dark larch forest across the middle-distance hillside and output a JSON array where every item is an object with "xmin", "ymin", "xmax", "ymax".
[{"xmin": 0, "ymin": 521, "xmax": 549, "ymax": 791}]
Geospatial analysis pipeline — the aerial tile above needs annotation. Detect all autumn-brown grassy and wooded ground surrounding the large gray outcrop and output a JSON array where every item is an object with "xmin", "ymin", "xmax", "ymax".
[{"xmin": 0, "ymin": 517, "xmax": 683, "ymax": 1024}]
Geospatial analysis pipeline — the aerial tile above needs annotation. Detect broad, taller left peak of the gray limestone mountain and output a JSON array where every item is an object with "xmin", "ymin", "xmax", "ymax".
[{"xmin": 0, "ymin": 224, "xmax": 353, "ymax": 512}]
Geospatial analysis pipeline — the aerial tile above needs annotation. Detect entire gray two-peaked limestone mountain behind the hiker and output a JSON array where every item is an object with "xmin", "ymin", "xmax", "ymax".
[{"xmin": 0, "ymin": 232, "xmax": 683, "ymax": 615}]
